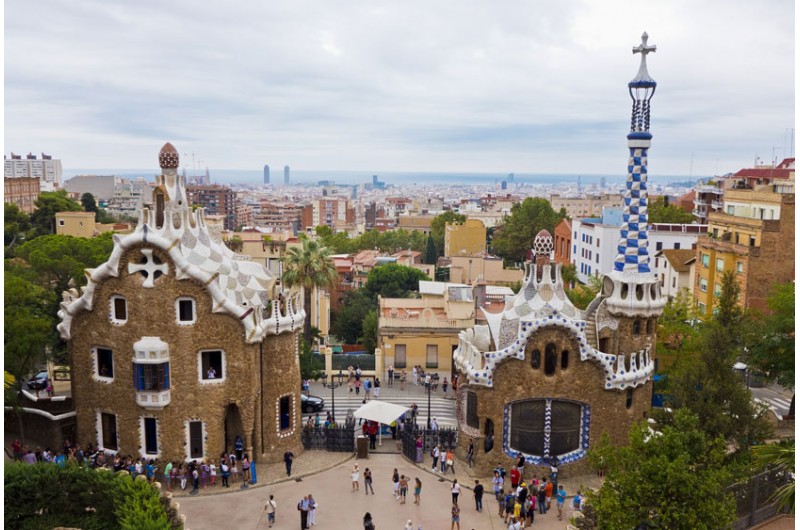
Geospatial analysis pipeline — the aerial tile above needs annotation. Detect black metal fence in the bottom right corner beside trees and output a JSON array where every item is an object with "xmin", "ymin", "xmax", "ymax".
[{"xmin": 727, "ymin": 469, "xmax": 792, "ymax": 530}]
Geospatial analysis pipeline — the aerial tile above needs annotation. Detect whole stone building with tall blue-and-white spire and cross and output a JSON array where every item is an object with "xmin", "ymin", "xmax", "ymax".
[{"xmin": 454, "ymin": 34, "xmax": 665, "ymax": 474}]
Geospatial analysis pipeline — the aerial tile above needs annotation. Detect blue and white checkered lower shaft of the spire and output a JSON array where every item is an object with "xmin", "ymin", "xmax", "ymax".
[{"xmin": 614, "ymin": 147, "xmax": 650, "ymax": 272}]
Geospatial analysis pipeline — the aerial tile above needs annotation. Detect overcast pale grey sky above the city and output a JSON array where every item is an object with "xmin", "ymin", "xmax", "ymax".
[{"xmin": 4, "ymin": 0, "xmax": 795, "ymax": 176}]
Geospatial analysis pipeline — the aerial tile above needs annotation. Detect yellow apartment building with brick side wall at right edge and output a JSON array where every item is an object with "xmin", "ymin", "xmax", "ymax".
[{"xmin": 693, "ymin": 184, "xmax": 794, "ymax": 318}]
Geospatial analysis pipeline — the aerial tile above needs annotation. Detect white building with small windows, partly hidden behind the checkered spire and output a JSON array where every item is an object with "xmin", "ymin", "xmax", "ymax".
[{"xmin": 570, "ymin": 207, "xmax": 708, "ymax": 283}]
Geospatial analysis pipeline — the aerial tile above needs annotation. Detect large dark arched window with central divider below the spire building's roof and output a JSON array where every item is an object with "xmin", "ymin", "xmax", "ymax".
[{"xmin": 508, "ymin": 399, "xmax": 586, "ymax": 463}]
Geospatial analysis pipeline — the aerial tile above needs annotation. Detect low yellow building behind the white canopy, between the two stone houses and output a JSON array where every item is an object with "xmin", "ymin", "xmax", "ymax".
[{"xmin": 376, "ymin": 281, "xmax": 475, "ymax": 374}]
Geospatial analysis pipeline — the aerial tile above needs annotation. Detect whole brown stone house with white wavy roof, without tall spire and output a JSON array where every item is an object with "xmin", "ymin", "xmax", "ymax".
[{"xmin": 58, "ymin": 143, "xmax": 305, "ymax": 461}]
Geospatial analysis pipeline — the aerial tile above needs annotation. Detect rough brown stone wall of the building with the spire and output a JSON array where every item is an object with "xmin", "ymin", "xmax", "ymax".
[{"xmin": 458, "ymin": 328, "xmax": 652, "ymax": 476}]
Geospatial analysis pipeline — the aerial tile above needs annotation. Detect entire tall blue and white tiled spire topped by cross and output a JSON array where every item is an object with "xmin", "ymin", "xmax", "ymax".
[{"xmin": 614, "ymin": 33, "xmax": 656, "ymax": 273}]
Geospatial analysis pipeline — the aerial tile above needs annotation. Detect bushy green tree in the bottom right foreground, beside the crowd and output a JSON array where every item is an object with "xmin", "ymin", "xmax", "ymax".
[{"xmin": 589, "ymin": 410, "xmax": 736, "ymax": 530}]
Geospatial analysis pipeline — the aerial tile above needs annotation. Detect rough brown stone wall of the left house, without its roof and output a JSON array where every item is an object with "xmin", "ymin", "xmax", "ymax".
[{"xmin": 69, "ymin": 243, "xmax": 300, "ymax": 460}]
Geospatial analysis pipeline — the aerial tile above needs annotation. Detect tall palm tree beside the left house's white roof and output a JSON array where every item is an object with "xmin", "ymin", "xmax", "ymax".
[{"xmin": 283, "ymin": 239, "xmax": 336, "ymax": 344}]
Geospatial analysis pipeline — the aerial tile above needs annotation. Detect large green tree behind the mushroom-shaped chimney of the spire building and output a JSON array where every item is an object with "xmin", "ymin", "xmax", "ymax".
[{"xmin": 492, "ymin": 197, "xmax": 563, "ymax": 263}]
